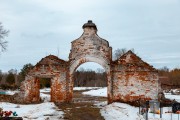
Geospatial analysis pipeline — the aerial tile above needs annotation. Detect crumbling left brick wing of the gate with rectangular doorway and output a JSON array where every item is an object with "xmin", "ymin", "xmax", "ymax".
[{"xmin": 21, "ymin": 55, "xmax": 68, "ymax": 102}]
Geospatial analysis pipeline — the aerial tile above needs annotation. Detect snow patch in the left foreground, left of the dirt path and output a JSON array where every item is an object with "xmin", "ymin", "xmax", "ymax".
[{"xmin": 0, "ymin": 102, "xmax": 63, "ymax": 120}]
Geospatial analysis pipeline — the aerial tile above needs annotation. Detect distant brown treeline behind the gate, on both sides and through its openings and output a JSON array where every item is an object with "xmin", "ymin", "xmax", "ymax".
[{"xmin": 0, "ymin": 64, "xmax": 180, "ymax": 89}]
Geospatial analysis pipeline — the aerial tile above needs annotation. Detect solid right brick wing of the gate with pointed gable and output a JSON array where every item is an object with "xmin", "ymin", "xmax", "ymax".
[{"xmin": 111, "ymin": 51, "xmax": 158, "ymax": 102}]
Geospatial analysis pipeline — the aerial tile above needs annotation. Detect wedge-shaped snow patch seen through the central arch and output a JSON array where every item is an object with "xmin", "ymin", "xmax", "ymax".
[{"xmin": 83, "ymin": 87, "xmax": 107, "ymax": 97}]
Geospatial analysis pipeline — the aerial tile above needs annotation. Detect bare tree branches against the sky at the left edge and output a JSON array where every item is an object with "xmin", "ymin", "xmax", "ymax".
[{"xmin": 0, "ymin": 22, "xmax": 9, "ymax": 52}]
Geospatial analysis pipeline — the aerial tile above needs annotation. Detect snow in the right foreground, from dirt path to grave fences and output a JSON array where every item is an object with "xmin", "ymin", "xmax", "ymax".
[{"xmin": 96, "ymin": 102, "xmax": 180, "ymax": 120}]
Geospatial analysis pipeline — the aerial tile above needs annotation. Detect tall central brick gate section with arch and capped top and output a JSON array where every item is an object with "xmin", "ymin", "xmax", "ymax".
[{"xmin": 68, "ymin": 21, "xmax": 112, "ymax": 102}]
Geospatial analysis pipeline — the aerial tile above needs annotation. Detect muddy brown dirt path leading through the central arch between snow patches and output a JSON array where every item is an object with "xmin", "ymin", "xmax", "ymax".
[{"xmin": 58, "ymin": 91, "xmax": 107, "ymax": 120}]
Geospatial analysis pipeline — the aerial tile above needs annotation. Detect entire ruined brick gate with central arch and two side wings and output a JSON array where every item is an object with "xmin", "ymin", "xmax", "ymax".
[{"xmin": 21, "ymin": 21, "xmax": 159, "ymax": 103}]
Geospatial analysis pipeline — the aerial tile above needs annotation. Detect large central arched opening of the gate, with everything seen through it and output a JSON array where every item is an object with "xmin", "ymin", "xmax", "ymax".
[{"xmin": 72, "ymin": 62, "xmax": 107, "ymax": 103}]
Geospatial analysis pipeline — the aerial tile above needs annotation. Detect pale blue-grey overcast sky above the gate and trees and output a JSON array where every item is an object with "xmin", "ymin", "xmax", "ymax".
[{"xmin": 0, "ymin": 0, "xmax": 180, "ymax": 72}]
